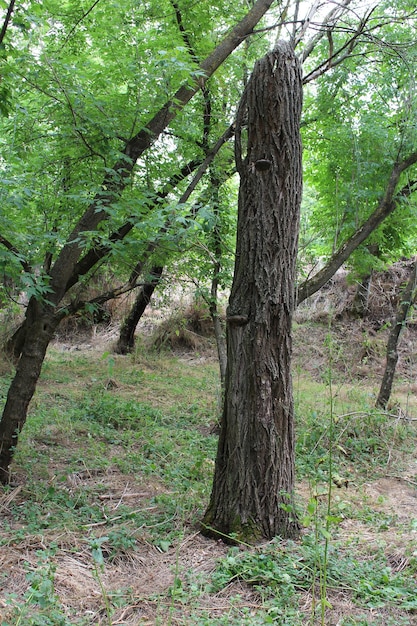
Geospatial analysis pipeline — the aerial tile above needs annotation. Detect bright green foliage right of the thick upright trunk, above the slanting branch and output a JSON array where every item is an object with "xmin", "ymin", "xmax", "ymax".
[{"xmin": 304, "ymin": 11, "xmax": 416, "ymax": 276}]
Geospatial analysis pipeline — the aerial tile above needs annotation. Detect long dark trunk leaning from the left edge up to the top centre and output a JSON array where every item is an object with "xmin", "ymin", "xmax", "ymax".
[{"xmin": 0, "ymin": 0, "xmax": 273, "ymax": 482}]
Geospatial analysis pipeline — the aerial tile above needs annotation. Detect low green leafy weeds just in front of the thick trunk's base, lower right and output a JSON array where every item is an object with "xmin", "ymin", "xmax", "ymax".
[{"xmin": 212, "ymin": 535, "xmax": 416, "ymax": 611}]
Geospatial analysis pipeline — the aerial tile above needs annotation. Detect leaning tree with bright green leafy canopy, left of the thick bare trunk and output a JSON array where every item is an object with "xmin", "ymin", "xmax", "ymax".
[{"xmin": 0, "ymin": 0, "xmax": 413, "ymax": 498}]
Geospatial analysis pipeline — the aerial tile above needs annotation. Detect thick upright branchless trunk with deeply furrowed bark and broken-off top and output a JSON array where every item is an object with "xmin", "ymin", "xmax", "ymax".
[{"xmin": 203, "ymin": 42, "xmax": 302, "ymax": 541}]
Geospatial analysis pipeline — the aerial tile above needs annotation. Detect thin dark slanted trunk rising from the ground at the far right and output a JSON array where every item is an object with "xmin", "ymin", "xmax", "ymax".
[{"xmin": 375, "ymin": 260, "xmax": 417, "ymax": 409}]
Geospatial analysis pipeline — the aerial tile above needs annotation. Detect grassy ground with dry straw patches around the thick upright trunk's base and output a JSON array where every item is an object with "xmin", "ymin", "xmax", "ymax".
[{"xmin": 0, "ymin": 336, "xmax": 417, "ymax": 626}]
